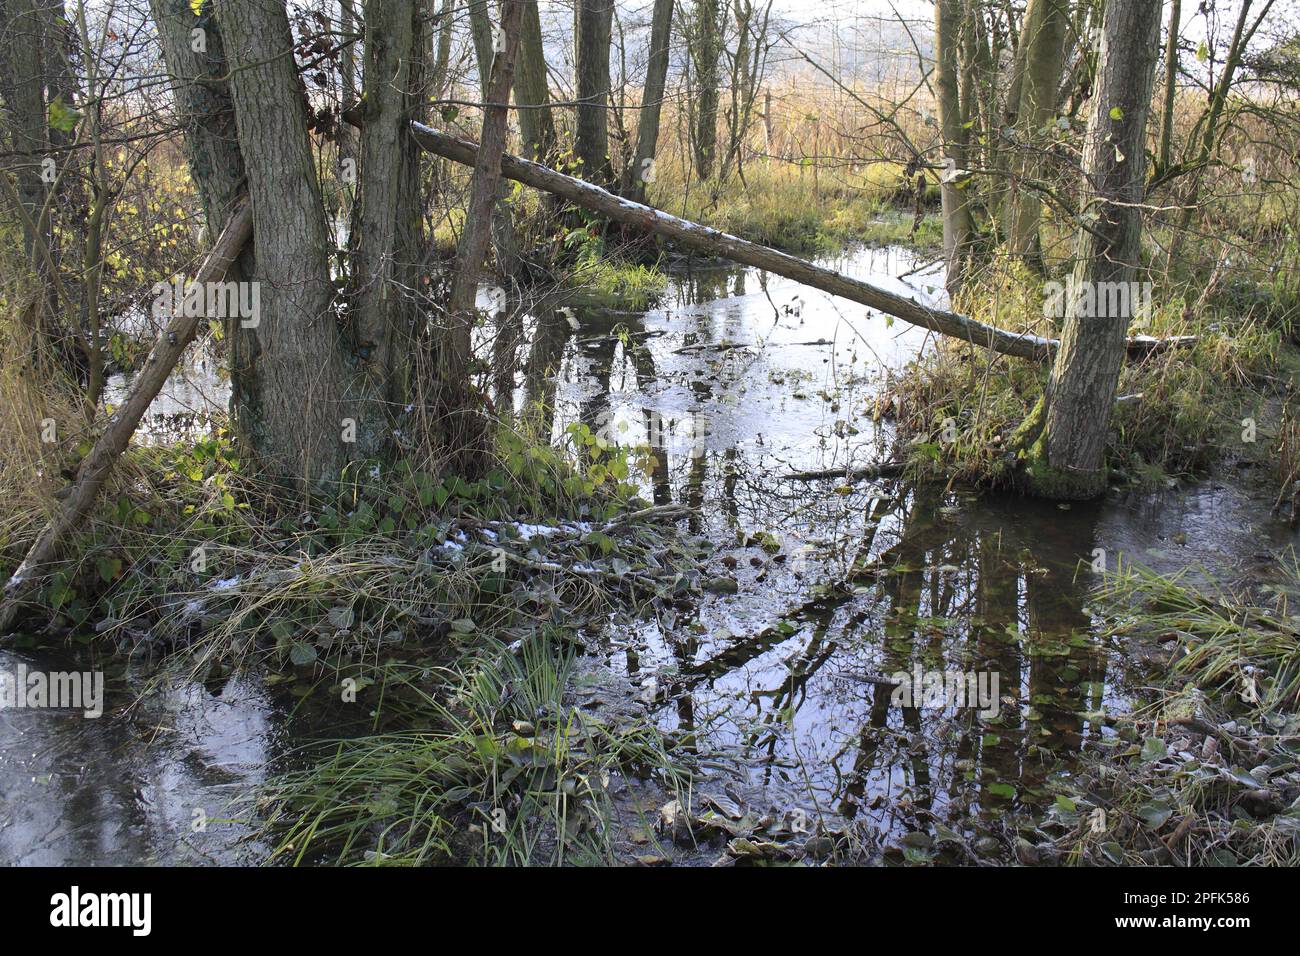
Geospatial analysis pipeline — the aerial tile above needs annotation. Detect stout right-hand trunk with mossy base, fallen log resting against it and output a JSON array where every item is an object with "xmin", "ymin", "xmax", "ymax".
[{"xmin": 1027, "ymin": 0, "xmax": 1161, "ymax": 498}]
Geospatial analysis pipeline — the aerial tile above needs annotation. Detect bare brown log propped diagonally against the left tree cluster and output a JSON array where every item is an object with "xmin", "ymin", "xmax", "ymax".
[{"xmin": 0, "ymin": 203, "xmax": 252, "ymax": 633}]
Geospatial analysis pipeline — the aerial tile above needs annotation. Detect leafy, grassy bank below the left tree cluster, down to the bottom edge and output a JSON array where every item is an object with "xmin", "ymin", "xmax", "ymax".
[{"xmin": 0, "ymin": 400, "xmax": 722, "ymax": 864}]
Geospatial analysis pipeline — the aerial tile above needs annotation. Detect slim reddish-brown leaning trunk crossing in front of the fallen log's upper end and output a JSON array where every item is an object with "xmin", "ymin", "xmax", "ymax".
[{"xmin": 438, "ymin": 0, "xmax": 524, "ymax": 471}]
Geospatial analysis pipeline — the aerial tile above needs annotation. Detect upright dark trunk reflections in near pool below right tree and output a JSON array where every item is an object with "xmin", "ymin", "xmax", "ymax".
[{"xmin": 845, "ymin": 490, "xmax": 1105, "ymax": 827}]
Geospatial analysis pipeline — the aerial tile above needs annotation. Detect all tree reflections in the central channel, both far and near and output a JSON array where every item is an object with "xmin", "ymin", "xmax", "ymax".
[{"xmin": 512, "ymin": 271, "xmax": 1105, "ymax": 832}]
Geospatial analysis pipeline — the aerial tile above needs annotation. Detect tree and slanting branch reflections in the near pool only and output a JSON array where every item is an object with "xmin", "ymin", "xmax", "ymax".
[{"xmin": 637, "ymin": 488, "xmax": 1105, "ymax": 832}]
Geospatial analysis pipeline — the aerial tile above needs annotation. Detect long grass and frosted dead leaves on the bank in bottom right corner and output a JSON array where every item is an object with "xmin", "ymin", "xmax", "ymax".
[{"xmin": 1034, "ymin": 555, "xmax": 1300, "ymax": 866}]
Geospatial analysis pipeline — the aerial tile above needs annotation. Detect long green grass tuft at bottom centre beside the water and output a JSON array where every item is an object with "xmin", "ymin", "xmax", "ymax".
[{"xmin": 247, "ymin": 628, "xmax": 689, "ymax": 866}]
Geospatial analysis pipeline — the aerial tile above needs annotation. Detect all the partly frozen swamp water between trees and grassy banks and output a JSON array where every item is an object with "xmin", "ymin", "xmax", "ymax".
[{"xmin": 0, "ymin": 250, "xmax": 1295, "ymax": 864}]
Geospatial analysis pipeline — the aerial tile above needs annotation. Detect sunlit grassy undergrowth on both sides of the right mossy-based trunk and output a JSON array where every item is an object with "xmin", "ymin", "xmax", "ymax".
[{"xmin": 875, "ymin": 254, "xmax": 1300, "ymax": 488}]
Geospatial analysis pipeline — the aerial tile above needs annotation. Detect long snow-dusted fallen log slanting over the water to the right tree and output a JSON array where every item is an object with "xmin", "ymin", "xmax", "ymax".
[{"xmin": 403, "ymin": 126, "xmax": 1195, "ymax": 360}]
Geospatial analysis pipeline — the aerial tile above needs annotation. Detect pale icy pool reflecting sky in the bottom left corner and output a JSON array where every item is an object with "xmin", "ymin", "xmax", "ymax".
[{"xmin": 0, "ymin": 652, "xmax": 274, "ymax": 866}]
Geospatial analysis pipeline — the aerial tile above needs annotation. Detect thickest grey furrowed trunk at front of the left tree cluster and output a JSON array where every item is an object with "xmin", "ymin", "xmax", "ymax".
[{"xmin": 217, "ymin": 0, "xmax": 359, "ymax": 489}]
